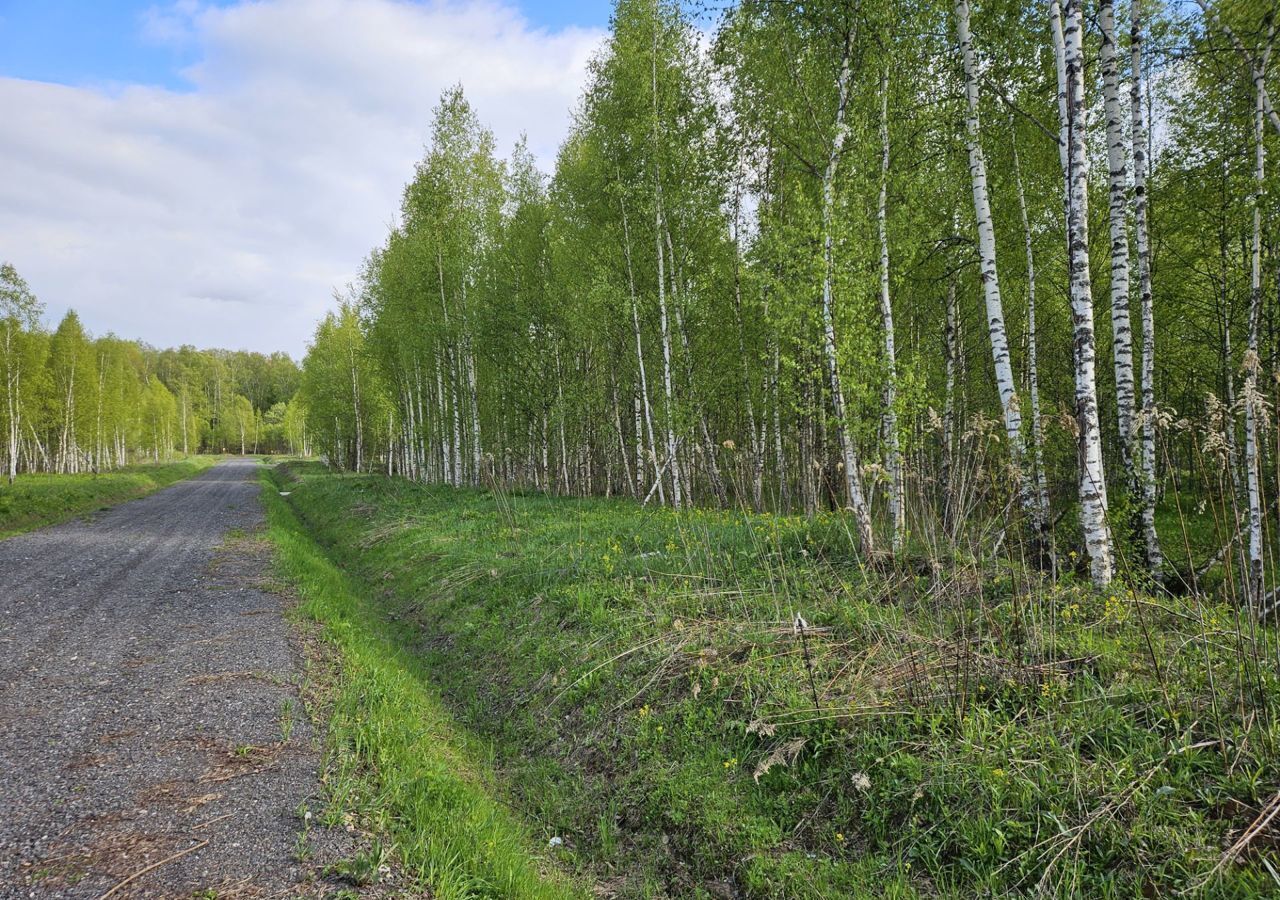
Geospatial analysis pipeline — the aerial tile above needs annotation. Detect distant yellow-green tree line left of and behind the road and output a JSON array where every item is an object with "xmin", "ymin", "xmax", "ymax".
[{"xmin": 0, "ymin": 262, "xmax": 305, "ymax": 481}]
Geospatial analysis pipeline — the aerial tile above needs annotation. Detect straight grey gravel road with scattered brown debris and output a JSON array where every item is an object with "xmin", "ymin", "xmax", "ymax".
[{"xmin": 0, "ymin": 460, "xmax": 342, "ymax": 897}]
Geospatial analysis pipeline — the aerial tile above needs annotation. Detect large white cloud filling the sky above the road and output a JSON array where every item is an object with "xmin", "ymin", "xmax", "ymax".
[{"xmin": 0, "ymin": 0, "xmax": 602, "ymax": 355}]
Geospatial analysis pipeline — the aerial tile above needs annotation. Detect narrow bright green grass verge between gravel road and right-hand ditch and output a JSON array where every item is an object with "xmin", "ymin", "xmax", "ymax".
[{"xmin": 264, "ymin": 468, "xmax": 585, "ymax": 900}]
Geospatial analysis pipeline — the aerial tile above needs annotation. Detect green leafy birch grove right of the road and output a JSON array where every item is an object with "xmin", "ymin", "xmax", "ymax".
[{"xmin": 294, "ymin": 0, "xmax": 1280, "ymax": 591}]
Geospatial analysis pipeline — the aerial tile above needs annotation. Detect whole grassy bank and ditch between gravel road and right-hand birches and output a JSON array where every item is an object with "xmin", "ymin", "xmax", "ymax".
[{"xmin": 262, "ymin": 466, "xmax": 1280, "ymax": 897}]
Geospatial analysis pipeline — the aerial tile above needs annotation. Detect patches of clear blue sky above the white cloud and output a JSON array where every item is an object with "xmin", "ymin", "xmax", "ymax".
[{"xmin": 0, "ymin": 0, "xmax": 613, "ymax": 91}]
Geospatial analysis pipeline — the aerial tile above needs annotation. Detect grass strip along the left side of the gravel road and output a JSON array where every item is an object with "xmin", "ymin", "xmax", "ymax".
[{"xmin": 0, "ymin": 456, "xmax": 219, "ymax": 538}]
